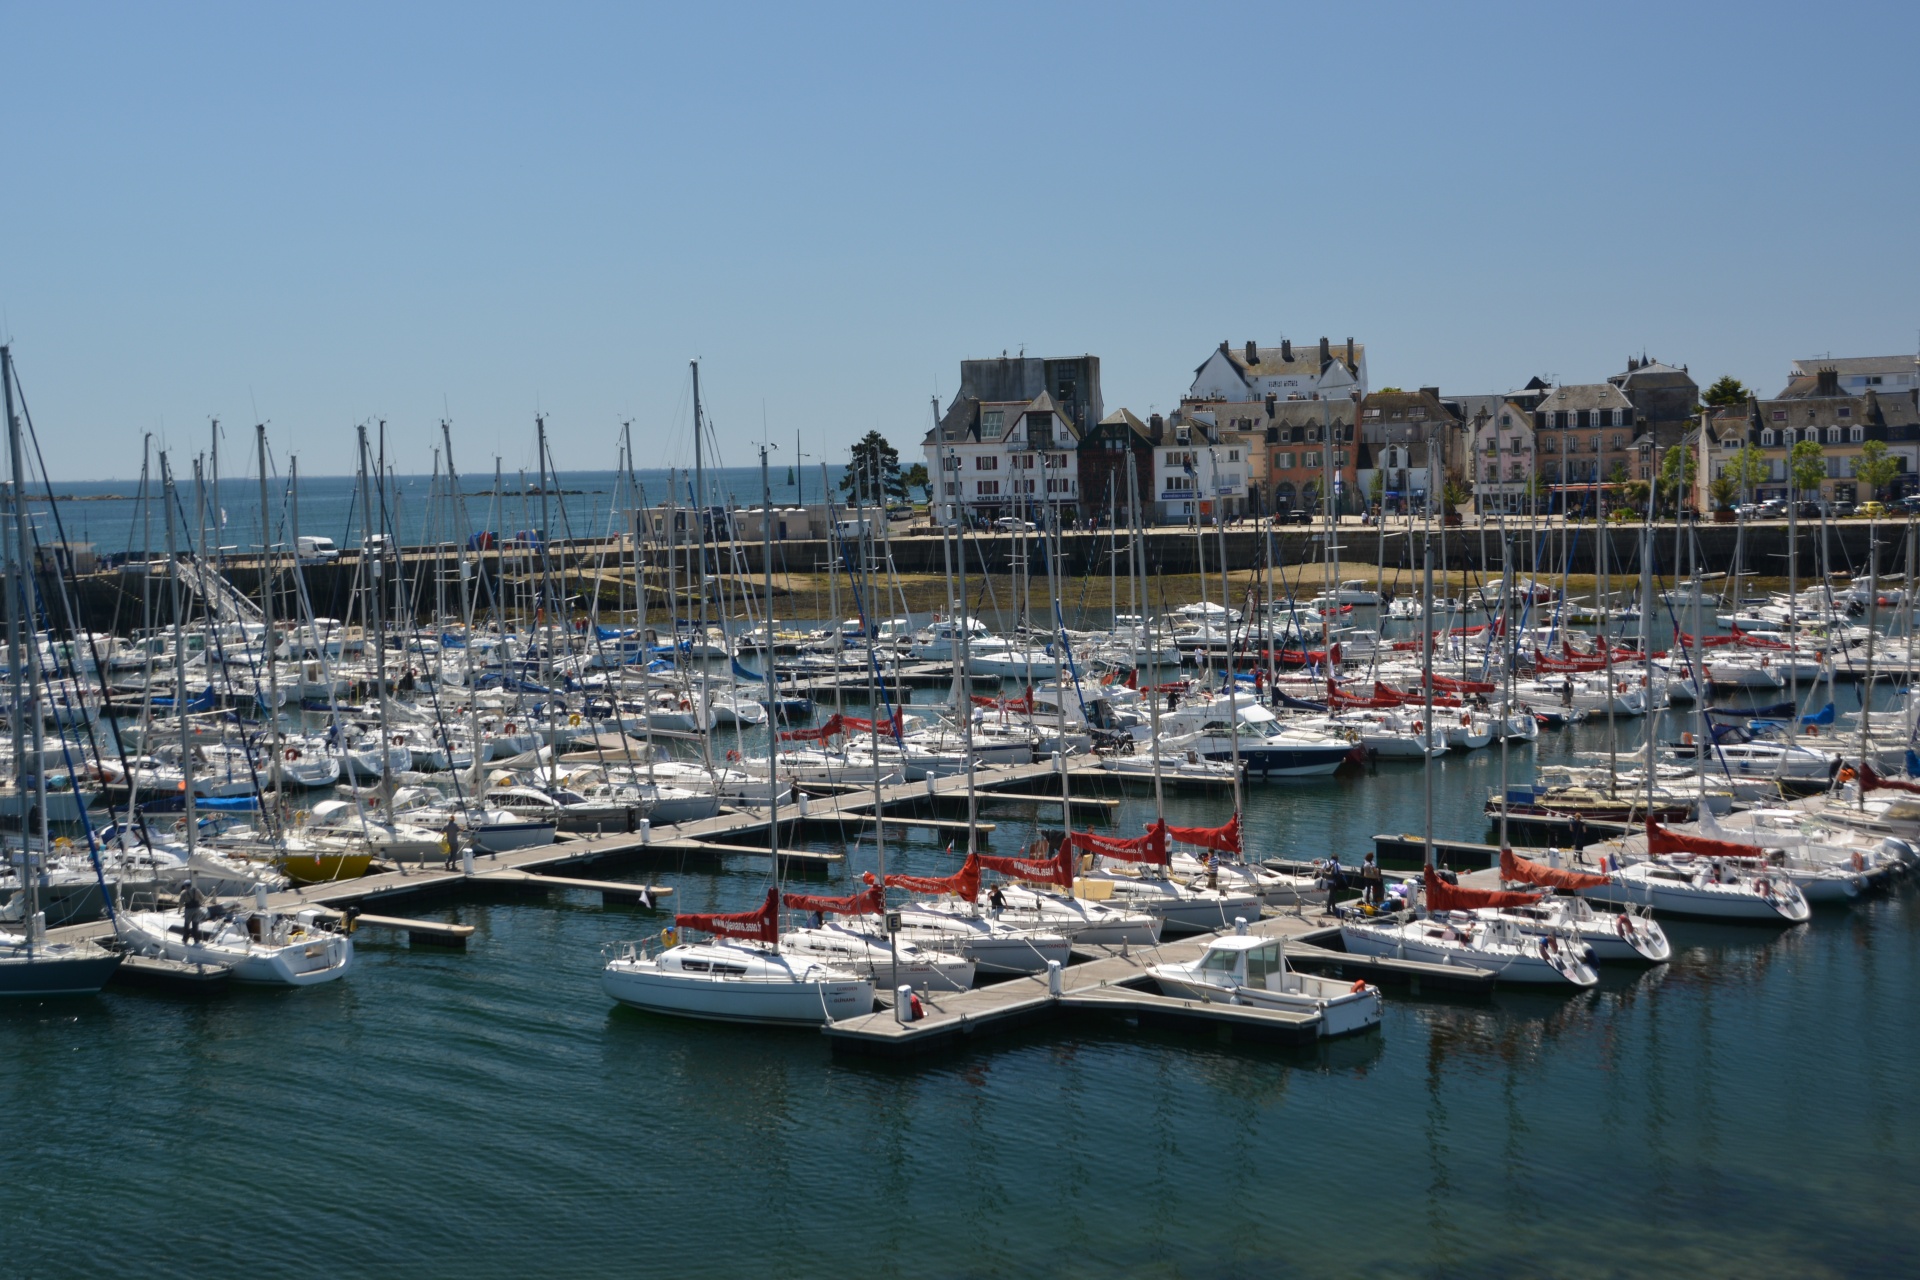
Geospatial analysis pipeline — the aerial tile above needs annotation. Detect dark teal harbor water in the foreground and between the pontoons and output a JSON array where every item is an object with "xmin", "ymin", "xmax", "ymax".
[{"xmin": 0, "ymin": 689, "xmax": 1920, "ymax": 1276}]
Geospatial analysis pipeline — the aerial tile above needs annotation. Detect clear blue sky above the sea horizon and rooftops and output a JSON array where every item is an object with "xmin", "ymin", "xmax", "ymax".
[{"xmin": 0, "ymin": 0, "xmax": 1920, "ymax": 480}]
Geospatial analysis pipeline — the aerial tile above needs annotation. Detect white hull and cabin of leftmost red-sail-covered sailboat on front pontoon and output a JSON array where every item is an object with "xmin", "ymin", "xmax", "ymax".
[{"xmin": 601, "ymin": 940, "xmax": 874, "ymax": 1027}]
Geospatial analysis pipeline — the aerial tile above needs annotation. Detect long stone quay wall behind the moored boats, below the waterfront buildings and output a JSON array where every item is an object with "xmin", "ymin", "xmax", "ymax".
[{"xmin": 42, "ymin": 520, "xmax": 1912, "ymax": 633}]
